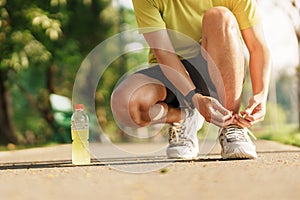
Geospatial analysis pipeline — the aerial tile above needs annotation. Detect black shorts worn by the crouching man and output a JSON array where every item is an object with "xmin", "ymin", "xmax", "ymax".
[{"xmin": 137, "ymin": 56, "xmax": 217, "ymax": 108}]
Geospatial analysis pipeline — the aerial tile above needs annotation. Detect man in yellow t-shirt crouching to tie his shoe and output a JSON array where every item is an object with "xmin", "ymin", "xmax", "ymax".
[{"xmin": 111, "ymin": 0, "xmax": 270, "ymax": 159}]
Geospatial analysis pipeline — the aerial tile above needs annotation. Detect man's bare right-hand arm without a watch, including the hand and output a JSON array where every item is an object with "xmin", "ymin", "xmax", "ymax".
[{"xmin": 237, "ymin": 25, "xmax": 271, "ymax": 127}]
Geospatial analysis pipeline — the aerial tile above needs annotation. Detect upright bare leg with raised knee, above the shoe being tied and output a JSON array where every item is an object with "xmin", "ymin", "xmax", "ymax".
[{"xmin": 202, "ymin": 7, "xmax": 244, "ymax": 114}]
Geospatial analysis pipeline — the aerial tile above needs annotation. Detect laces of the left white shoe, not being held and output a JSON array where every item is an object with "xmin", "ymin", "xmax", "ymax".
[{"xmin": 169, "ymin": 123, "xmax": 187, "ymax": 145}]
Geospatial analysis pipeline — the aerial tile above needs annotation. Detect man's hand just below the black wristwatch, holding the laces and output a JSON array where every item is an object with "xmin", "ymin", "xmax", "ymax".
[{"xmin": 193, "ymin": 94, "xmax": 234, "ymax": 127}]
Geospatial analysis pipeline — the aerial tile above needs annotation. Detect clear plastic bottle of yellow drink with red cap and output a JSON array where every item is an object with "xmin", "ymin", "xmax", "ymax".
[{"xmin": 71, "ymin": 104, "xmax": 91, "ymax": 165}]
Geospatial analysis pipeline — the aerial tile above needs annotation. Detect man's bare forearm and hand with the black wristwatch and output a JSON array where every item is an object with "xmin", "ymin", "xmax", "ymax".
[{"xmin": 144, "ymin": 30, "xmax": 232, "ymax": 126}]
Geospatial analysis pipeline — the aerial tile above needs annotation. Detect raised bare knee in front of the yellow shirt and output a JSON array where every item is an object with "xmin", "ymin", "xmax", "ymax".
[{"xmin": 202, "ymin": 6, "xmax": 238, "ymax": 32}]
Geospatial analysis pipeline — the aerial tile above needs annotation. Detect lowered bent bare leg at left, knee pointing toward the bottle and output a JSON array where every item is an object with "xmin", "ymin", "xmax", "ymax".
[{"xmin": 111, "ymin": 74, "xmax": 183, "ymax": 127}]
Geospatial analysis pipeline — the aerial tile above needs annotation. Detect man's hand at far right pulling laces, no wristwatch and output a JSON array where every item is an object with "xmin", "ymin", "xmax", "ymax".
[{"xmin": 234, "ymin": 94, "xmax": 266, "ymax": 128}]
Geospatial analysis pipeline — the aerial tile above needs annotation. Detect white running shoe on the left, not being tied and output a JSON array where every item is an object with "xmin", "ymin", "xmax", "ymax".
[{"xmin": 167, "ymin": 109, "xmax": 204, "ymax": 159}]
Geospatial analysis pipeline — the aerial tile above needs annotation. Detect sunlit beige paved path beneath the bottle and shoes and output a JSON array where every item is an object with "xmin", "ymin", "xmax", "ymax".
[{"xmin": 0, "ymin": 141, "xmax": 300, "ymax": 200}]
